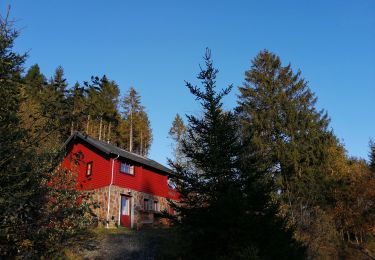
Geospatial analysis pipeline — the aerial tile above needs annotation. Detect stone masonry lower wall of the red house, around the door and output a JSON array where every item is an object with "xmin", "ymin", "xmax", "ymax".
[{"xmin": 92, "ymin": 185, "xmax": 173, "ymax": 229}]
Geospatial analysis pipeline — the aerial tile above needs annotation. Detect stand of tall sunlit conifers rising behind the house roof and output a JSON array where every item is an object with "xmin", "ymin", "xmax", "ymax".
[{"xmin": 19, "ymin": 59, "xmax": 152, "ymax": 156}]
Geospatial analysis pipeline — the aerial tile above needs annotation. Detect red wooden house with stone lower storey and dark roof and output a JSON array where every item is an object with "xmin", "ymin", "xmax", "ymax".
[{"xmin": 63, "ymin": 132, "xmax": 178, "ymax": 228}]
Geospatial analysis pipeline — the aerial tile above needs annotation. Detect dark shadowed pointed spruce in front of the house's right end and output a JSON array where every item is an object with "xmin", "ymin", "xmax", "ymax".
[{"xmin": 171, "ymin": 50, "xmax": 303, "ymax": 259}]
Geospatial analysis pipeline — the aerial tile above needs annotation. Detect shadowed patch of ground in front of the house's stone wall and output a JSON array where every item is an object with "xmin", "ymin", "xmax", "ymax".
[{"xmin": 66, "ymin": 228, "xmax": 178, "ymax": 260}]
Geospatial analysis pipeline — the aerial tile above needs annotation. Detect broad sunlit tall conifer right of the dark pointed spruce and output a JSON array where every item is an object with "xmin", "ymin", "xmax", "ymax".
[{"xmin": 238, "ymin": 51, "xmax": 341, "ymax": 257}]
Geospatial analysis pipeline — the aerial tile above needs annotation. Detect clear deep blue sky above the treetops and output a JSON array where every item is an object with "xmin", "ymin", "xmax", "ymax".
[{"xmin": 0, "ymin": 0, "xmax": 375, "ymax": 166}]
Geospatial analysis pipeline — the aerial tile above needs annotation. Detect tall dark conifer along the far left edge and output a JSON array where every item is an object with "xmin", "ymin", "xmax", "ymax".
[{"xmin": 0, "ymin": 13, "xmax": 47, "ymax": 258}]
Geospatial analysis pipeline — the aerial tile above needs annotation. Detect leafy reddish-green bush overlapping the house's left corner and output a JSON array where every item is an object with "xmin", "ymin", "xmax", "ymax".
[{"xmin": 34, "ymin": 154, "xmax": 98, "ymax": 255}]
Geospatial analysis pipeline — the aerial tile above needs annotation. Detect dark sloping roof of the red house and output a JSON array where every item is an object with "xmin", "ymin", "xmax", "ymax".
[{"xmin": 63, "ymin": 132, "xmax": 173, "ymax": 175}]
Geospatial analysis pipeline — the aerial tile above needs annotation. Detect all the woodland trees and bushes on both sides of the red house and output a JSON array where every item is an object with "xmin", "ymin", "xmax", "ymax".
[{"xmin": 0, "ymin": 11, "xmax": 375, "ymax": 259}]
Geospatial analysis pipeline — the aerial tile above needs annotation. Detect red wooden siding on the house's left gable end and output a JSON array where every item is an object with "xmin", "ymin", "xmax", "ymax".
[{"xmin": 63, "ymin": 143, "xmax": 112, "ymax": 190}]
